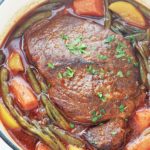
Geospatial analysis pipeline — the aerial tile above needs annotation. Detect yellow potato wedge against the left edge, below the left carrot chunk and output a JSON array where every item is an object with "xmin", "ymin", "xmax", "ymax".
[{"xmin": 0, "ymin": 103, "xmax": 20, "ymax": 129}]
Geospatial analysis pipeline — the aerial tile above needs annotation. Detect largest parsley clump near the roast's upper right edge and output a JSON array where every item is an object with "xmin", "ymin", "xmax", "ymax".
[{"xmin": 116, "ymin": 42, "xmax": 126, "ymax": 58}]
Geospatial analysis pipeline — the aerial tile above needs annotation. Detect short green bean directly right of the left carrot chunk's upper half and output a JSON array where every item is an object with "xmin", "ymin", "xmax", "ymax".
[{"xmin": 27, "ymin": 67, "xmax": 41, "ymax": 94}]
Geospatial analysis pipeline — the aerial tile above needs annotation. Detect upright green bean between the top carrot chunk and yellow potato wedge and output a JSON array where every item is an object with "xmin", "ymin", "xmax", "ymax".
[{"xmin": 104, "ymin": 0, "xmax": 112, "ymax": 29}]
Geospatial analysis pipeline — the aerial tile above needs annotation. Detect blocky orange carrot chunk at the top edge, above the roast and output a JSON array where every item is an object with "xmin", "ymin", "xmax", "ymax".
[{"xmin": 73, "ymin": 0, "xmax": 104, "ymax": 17}]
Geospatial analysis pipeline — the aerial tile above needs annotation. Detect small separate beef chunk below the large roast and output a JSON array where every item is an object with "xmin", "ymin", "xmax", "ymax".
[{"xmin": 84, "ymin": 118, "xmax": 126, "ymax": 150}]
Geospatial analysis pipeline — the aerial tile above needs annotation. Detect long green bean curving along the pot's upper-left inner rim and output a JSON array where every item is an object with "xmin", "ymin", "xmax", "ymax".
[{"xmin": 13, "ymin": 11, "xmax": 51, "ymax": 38}]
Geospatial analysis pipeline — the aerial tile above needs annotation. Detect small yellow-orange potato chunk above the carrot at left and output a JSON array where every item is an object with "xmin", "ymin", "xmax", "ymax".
[{"xmin": 8, "ymin": 52, "xmax": 24, "ymax": 73}]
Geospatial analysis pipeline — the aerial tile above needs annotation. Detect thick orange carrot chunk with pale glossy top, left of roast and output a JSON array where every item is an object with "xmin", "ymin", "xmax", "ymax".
[{"xmin": 10, "ymin": 77, "xmax": 38, "ymax": 110}]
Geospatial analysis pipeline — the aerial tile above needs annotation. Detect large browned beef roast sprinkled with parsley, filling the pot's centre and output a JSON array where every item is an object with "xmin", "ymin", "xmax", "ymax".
[{"xmin": 24, "ymin": 15, "xmax": 140, "ymax": 125}]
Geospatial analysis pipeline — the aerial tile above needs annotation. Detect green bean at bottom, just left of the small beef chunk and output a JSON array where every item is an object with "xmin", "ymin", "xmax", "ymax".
[{"xmin": 48, "ymin": 125, "xmax": 85, "ymax": 147}]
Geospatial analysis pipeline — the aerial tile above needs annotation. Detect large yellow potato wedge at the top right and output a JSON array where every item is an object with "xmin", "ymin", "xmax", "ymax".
[{"xmin": 109, "ymin": 1, "xmax": 147, "ymax": 28}]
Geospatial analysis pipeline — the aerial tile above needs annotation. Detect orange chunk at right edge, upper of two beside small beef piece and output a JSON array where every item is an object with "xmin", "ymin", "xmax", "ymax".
[{"xmin": 133, "ymin": 108, "xmax": 150, "ymax": 132}]
